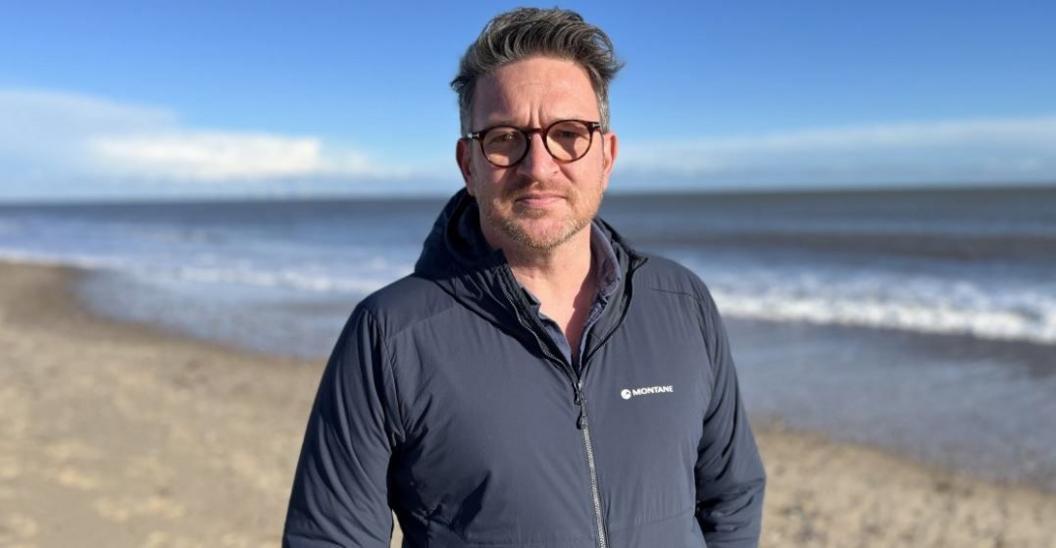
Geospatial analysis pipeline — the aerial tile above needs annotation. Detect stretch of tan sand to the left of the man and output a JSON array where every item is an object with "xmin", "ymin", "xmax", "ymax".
[{"xmin": 0, "ymin": 262, "xmax": 322, "ymax": 547}]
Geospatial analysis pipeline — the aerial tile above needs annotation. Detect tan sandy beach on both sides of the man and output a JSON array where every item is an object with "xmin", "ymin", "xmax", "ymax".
[{"xmin": 0, "ymin": 264, "xmax": 1056, "ymax": 547}]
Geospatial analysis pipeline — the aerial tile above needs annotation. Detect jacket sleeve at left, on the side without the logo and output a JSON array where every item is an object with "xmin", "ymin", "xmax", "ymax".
[{"xmin": 282, "ymin": 305, "xmax": 396, "ymax": 548}]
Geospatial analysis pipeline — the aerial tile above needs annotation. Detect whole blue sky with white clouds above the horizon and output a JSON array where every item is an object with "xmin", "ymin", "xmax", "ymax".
[{"xmin": 0, "ymin": 1, "xmax": 1056, "ymax": 201}]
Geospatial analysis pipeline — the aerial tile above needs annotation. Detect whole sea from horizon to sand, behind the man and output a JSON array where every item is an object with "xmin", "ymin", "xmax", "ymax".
[{"xmin": 0, "ymin": 187, "xmax": 1056, "ymax": 491}]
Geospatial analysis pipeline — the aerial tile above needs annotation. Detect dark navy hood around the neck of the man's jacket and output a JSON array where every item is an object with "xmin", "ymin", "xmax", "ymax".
[{"xmin": 414, "ymin": 188, "xmax": 645, "ymax": 367}]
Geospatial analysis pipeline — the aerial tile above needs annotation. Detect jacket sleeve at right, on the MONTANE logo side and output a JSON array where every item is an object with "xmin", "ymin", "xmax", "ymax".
[{"xmin": 695, "ymin": 288, "xmax": 766, "ymax": 548}]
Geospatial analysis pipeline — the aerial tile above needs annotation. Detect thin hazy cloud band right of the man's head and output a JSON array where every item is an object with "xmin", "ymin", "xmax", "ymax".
[{"xmin": 618, "ymin": 116, "xmax": 1056, "ymax": 186}]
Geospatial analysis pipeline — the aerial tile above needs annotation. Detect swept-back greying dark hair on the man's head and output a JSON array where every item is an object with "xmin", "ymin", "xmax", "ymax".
[{"xmin": 451, "ymin": 7, "xmax": 623, "ymax": 135}]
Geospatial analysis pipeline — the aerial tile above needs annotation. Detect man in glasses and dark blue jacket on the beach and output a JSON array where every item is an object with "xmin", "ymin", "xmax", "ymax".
[{"xmin": 284, "ymin": 8, "xmax": 765, "ymax": 548}]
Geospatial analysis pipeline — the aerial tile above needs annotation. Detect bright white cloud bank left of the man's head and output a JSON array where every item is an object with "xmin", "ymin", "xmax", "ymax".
[{"xmin": 0, "ymin": 85, "xmax": 411, "ymax": 187}]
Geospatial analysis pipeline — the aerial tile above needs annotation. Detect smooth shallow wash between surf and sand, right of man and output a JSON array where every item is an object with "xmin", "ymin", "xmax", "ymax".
[{"xmin": 728, "ymin": 319, "xmax": 1056, "ymax": 493}]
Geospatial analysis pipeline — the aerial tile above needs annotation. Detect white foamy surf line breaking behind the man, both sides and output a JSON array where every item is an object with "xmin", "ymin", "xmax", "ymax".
[{"xmin": 0, "ymin": 248, "xmax": 1056, "ymax": 344}]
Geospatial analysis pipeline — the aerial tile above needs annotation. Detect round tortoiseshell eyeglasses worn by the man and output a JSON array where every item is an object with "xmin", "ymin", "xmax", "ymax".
[{"xmin": 466, "ymin": 120, "xmax": 601, "ymax": 168}]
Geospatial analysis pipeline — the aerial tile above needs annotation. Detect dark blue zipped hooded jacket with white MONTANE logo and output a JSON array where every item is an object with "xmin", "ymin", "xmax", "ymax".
[{"xmin": 283, "ymin": 190, "xmax": 766, "ymax": 548}]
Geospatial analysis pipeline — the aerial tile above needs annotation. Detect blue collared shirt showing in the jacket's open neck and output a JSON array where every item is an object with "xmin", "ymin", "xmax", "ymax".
[{"xmin": 522, "ymin": 223, "xmax": 622, "ymax": 367}]
